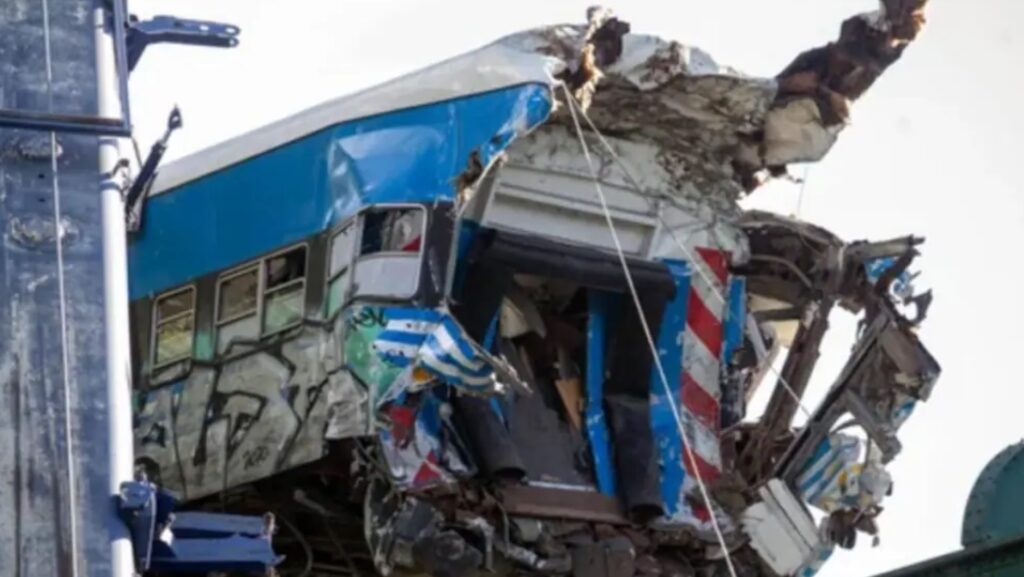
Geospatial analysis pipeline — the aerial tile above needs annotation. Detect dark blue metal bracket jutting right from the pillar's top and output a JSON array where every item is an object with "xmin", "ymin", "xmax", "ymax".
[{"xmin": 127, "ymin": 16, "xmax": 241, "ymax": 72}]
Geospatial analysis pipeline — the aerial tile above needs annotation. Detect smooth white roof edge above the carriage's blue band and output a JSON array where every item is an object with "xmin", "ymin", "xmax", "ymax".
[{"xmin": 150, "ymin": 42, "xmax": 561, "ymax": 195}]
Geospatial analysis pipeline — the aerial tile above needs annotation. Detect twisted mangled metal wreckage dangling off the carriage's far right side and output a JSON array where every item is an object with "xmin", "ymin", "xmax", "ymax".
[{"xmin": 739, "ymin": 213, "xmax": 940, "ymax": 575}]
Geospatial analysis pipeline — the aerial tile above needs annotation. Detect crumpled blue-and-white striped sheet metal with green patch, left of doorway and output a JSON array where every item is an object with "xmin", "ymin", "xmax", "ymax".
[{"xmin": 356, "ymin": 306, "xmax": 518, "ymax": 490}]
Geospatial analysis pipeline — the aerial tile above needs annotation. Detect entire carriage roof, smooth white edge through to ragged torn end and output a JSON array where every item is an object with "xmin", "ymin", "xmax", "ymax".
[{"xmin": 153, "ymin": 0, "xmax": 926, "ymax": 204}]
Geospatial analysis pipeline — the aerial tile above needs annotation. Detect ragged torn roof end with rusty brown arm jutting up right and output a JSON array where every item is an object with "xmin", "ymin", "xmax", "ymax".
[{"xmin": 493, "ymin": 0, "xmax": 927, "ymax": 199}]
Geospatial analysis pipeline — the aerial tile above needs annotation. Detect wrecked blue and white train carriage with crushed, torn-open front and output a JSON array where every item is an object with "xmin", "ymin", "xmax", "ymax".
[{"xmin": 130, "ymin": 5, "xmax": 937, "ymax": 575}]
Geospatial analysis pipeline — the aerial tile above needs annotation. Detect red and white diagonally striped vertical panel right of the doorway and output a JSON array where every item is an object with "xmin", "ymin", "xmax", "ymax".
[{"xmin": 680, "ymin": 247, "xmax": 729, "ymax": 488}]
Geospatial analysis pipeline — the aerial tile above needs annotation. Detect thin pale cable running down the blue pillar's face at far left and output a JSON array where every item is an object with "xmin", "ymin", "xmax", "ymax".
[{"xmin": 43, "ymin": 0, "xmax": 78, "ymax": 577}]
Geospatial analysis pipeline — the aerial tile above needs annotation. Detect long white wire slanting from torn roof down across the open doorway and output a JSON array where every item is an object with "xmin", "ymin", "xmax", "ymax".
[{"xmin": 561, "ymin": 83, "xmax": 737, "ymax": 577}]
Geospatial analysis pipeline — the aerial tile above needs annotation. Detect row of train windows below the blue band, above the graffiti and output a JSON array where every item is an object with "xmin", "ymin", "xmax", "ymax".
[{"xmin": 153, "ymin": 208, "xmax": 426, "ymax": 368}]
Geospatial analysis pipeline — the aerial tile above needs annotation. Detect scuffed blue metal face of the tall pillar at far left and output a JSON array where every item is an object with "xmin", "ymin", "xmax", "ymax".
[{"xmin": 0, "ymin": 0, "xmax": 121, "ymax": 577}]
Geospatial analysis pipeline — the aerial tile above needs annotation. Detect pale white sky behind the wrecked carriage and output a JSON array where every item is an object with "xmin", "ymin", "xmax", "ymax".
[{"xmin": 131, "ymin": 0, "xmax": 1024, "ymax": 577}]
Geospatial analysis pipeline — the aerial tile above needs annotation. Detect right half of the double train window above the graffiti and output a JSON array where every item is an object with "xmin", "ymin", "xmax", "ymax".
[{"xmin": 263, "ymin": 246, "xmax": 306, "ymax": 334}]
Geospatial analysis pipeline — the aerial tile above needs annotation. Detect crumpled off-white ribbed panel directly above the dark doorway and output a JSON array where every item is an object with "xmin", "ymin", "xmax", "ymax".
[{"xmin": 495, "ymin": 123, "xmax": 750, "ymax": 264}]
